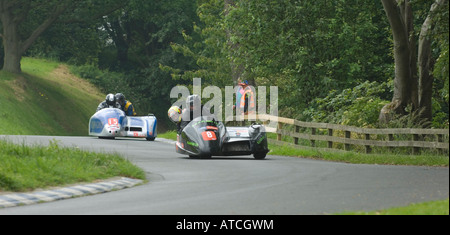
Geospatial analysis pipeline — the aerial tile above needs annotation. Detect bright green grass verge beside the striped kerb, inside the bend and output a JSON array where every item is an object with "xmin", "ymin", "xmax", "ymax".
[{"xmin": 0, "ymin": 141, "xmax": 145, "ymax": 192}]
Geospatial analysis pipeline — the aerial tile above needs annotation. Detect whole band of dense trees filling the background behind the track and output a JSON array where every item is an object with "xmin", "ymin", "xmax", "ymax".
[{"xmin": 0, "ymin": 0, "xmax": 448, "ymax": 127}]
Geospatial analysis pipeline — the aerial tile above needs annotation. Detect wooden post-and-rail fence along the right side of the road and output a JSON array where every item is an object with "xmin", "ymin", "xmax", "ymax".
[{"xmin": 227, "ymin": 115, "xmax": 449, "ymax": 154}]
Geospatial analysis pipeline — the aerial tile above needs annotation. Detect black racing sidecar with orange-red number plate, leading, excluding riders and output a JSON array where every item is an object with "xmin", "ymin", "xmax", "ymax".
[{"xmin": 176, "ymin": 116, "xmax": 269, "ymax": 159}]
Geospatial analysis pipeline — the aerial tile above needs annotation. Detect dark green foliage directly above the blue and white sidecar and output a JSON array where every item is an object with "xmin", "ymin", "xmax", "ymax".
[{"xmin": 91, "ymin": 0, "xmax": 198, "ymax": 127}]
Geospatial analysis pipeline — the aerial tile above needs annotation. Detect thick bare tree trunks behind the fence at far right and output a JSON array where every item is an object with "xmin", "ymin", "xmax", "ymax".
[{"xmin": 379, "ymin": 0, "xmax": 448, "ymax": 125}]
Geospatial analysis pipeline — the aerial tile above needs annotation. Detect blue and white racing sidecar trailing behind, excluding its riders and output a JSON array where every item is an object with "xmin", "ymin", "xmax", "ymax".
[{"xmin": 89, "ymin": 108, "xmax": 157, "ymax": 141}]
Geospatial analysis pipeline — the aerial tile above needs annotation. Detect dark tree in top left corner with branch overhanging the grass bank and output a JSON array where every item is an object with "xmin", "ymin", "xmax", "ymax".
[{"xmin": 0, "ymin": 0, "xmax": 126, "ymax": 73}]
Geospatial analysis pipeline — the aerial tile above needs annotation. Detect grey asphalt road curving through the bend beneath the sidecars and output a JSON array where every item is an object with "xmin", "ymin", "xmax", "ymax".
[{"xmin": 0, "ymin": 136, "xmax": 449, "ymax": 215}]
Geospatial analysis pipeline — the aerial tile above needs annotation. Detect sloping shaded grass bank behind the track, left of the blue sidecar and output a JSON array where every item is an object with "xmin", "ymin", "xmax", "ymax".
[{"xmin": 0, "ymin": 58, "xmax": 104, "ymax": 136}]
